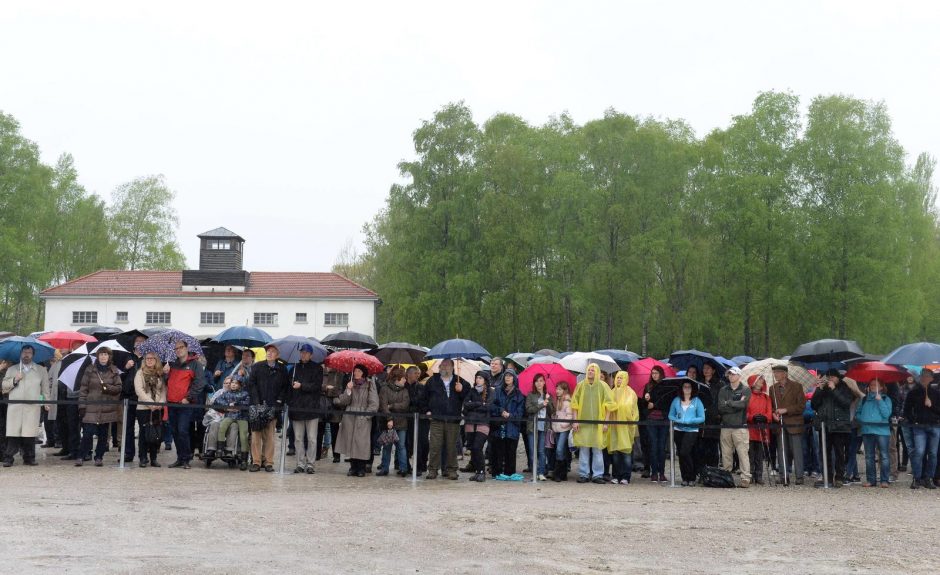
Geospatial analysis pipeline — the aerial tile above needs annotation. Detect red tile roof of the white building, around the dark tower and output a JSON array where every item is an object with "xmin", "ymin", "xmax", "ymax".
[{"xmin": 40, "ymin": 270, "xmax": 379, "ymax": 299}]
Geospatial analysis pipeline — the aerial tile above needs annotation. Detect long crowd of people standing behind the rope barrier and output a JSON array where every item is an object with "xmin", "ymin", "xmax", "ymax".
[{"xmin": 0, "ymin": 339, "xmax": 940, "ymax": 489}]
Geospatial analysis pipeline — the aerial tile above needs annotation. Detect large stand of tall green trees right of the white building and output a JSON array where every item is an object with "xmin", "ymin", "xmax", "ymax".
[{"xmin": 346, "ymin": 92, "xmax": 940, "ymax": 357}]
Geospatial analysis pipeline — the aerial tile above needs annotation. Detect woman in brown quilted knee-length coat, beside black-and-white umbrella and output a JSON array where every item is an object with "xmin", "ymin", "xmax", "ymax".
[{"xmin": 75, "ymin": 347, "xmax": 123, "ymax": 467}]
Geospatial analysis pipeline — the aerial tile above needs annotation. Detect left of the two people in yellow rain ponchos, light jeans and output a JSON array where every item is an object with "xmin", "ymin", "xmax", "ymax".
[{"xmin": 571, "ymin": 363, "xmax": 615, "ymax": 483}]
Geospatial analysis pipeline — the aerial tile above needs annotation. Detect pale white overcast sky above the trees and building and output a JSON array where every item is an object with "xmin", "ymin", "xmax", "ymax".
[{"xmin": 0, "ymin": 0, "xmax": 940, "ymax": 271}]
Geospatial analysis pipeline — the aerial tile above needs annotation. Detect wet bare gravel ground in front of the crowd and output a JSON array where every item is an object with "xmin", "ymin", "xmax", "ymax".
[{"xmin": 0, "ymin": 451, "xmax": 940, "ymax": 575}]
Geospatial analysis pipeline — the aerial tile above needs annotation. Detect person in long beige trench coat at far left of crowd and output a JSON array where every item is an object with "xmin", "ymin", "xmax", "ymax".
[{"xmin": 2, "ymin": 344, "xmax": 51, "ymax": 467}]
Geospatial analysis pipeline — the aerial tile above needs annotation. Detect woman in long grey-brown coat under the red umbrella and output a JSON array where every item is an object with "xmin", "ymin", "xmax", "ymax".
[{"xmin": 333, "ymin": 364, "xmax": 379, "ymax": 477}]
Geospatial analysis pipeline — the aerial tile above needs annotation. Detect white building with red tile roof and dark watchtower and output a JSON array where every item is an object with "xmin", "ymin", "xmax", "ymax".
[{"xmin": 40, "ymin": 228, "xmax": 379, "ymax": 339}]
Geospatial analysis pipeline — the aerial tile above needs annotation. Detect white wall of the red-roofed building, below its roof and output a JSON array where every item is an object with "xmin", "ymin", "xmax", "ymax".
[{"xmin": 44, "ymin": 297, "xmax": 375, "ymax": 339}]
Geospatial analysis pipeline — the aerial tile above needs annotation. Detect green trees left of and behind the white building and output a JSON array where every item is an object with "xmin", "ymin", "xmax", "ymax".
[{"xmin": 0, "ymin": 112, "xmax": 185, "ymax": 334}]
